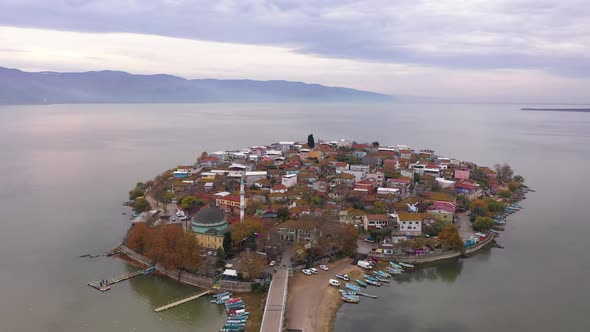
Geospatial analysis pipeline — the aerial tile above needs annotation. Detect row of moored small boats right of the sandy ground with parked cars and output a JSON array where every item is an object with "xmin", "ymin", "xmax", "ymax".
[{"xmin": 339, "ymin": 262, "xmax": 414, "ymax": 303}]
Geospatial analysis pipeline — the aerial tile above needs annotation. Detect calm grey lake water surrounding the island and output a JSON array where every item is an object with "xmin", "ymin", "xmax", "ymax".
[{"xmin": 0, "ymin": 105, "xmax": 590, "ymax": 332}]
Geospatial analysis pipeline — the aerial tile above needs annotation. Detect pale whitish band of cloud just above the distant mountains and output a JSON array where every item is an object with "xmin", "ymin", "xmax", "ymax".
[{"xmin": 0, "ymin": 26, "xmax": 590, "ymax": 102}]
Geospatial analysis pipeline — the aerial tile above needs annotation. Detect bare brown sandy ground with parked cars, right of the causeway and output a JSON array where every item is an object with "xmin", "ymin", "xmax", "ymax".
[{"xmin": 286, "ymin": 258, "xmax": 360, "ymax": 332}]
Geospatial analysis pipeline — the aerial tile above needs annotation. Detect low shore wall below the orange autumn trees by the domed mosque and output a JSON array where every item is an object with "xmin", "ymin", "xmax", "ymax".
[{"xmin": 121, "ymin": 245, "xmax": 252, "ymax": 292}]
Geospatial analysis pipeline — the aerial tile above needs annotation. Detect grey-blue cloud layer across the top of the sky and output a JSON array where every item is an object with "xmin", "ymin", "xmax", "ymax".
[{"xmin": 0, "ymin": 0, "xmax": 590, "ymax": 77}]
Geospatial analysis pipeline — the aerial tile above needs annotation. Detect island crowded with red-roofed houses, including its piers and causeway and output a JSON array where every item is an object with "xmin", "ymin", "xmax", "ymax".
[{"xmin": 95, "ymin": 134, "xmax": 530, "ymax": 332}]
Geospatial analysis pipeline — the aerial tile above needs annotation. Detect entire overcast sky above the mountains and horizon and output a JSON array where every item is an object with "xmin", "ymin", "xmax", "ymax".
[{"xmin": 0, "ymin": 0, "xmax": 590, "ymax": 103}]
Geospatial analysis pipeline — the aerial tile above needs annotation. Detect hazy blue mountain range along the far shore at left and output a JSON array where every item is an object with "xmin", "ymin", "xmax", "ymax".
[{"xmin": 0, "ymin": 67, "xmax": 394, "ymax": 104}]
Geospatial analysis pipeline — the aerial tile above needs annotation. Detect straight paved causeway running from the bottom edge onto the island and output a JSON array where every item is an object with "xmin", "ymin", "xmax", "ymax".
[{"xmin": 260, "ymin": 266, "xmax": 289, "ymax": 332}]
